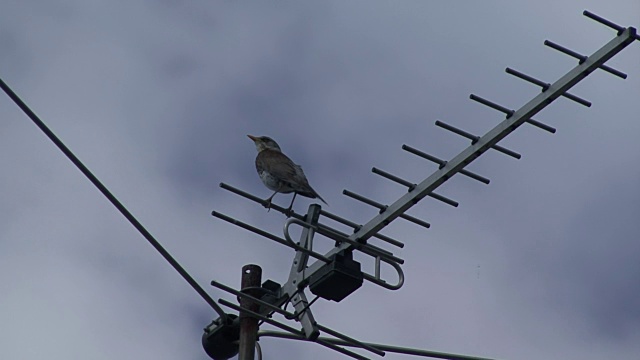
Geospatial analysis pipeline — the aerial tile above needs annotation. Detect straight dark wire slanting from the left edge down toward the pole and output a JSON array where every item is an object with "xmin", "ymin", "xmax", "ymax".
[{"xmin": 0, "ymin": 79, "xmax": 227, "ymax": 320}]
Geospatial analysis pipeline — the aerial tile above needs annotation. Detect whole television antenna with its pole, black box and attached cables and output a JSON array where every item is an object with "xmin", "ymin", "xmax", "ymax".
[{"xmin": 0, "ymin": 7, "xmax": 640, "ymax": 360}]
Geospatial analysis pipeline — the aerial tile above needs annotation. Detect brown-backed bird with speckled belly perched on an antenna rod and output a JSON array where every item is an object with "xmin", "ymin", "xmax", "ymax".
[{"xmin": 247, "ymin": 135, "xmax": 329, "ymax": 216}]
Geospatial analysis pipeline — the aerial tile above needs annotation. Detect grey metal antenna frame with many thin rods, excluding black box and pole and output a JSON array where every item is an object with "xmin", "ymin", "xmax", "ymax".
[{"xmin": 211, "ymin": 11, "xmax": 640, "ymax": 360}]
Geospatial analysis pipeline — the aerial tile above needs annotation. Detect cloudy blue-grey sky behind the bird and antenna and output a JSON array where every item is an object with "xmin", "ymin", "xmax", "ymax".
[{"xmin": 0, "ymin": 0, "xmax": 640, "ymax": 360}]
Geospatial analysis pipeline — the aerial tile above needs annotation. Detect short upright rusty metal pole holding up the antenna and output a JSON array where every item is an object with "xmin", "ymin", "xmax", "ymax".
[{"xmin": 238, "ymin": 264, "xmax": 262, "ymax": 360}]
